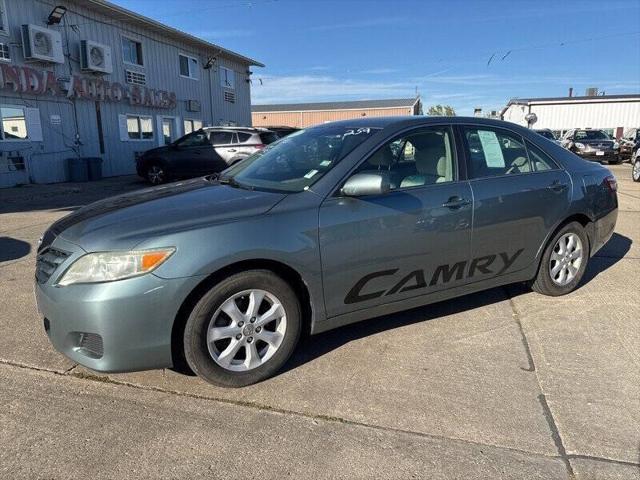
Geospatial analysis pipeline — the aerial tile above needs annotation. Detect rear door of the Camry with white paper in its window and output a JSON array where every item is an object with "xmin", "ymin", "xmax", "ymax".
[{"xmin": 461, "ymin": 125, "xmax": 571, "ymax": 281}]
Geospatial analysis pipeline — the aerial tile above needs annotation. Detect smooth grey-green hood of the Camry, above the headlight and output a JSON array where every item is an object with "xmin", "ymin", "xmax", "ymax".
[{"xmin": 48, "ymin": 178, "xmax": 286, "ymax": 251}]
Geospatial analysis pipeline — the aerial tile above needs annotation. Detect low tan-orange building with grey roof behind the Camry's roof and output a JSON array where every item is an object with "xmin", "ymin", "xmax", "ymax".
[{"xmin": 251, "ymin": 97, "xmax": 422, "ymax": 128}]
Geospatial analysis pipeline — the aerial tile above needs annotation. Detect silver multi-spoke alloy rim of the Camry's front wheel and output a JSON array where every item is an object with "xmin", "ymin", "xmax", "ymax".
[{"xmin": 207, "ymin": 289, "xmax": 287, "ymax": 372}]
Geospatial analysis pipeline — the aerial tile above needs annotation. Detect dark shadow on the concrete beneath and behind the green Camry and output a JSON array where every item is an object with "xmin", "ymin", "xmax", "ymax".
[{"xmin": 280, "ymin": 233, "xmax": 632, "ymax": 374}]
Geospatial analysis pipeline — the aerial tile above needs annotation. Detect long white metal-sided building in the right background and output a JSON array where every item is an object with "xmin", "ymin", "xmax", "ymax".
[{"xmin": 502, "ymin": 94, "xmax": 640, "ymax": 137}]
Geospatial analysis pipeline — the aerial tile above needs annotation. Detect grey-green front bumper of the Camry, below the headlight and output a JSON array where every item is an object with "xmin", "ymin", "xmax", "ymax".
[{"xmin": 35, "ymin": 239, "xmax": 203, "ymax": 372}]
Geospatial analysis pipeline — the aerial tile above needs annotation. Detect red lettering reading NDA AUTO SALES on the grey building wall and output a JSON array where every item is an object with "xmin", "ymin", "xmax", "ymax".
[{"xmin": 0, "ymin": 63, "xmax": 177, "ymax": 108}]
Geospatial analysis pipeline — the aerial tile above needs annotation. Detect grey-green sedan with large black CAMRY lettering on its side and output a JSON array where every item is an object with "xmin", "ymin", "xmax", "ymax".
[{"xmin": 35, "ymin": 116, "xmax": 618, "ymax": 387}]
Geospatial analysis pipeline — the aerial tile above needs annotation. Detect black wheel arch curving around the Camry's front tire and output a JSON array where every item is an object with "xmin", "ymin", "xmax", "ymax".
[{"xmin": 171, "ymin": 259, "xmax": 313, "ymax": 372}]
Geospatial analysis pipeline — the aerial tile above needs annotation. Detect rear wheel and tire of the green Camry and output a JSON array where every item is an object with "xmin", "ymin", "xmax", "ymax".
[{"xmin": 531, "ymin": 222, "xmax": 589, "ymax": 297}]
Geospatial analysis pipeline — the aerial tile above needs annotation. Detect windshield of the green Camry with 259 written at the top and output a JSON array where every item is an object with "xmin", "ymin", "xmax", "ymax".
[{"xmin": 221, "ymin": 125, "xmax": 379, "ymax": 192}]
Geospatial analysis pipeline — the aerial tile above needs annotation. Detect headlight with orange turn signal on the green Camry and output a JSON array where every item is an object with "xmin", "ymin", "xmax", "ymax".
[{"xmin": 58, "ymin": 247, "xmax": 176, "ymax": 286}]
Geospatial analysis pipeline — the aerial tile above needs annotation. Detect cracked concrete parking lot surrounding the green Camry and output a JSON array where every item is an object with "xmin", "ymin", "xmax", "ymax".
[{"xmin": 0, "ymin": 164, "xmax": 640, "ymax": 479}]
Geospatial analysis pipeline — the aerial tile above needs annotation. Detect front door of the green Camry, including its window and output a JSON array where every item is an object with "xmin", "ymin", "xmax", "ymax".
[{"xmin": 320, "ymin": 127, "xmax": 472, "ymax": 317}]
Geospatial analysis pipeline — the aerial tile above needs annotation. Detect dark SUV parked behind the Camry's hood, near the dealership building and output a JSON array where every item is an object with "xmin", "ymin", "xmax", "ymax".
[{"xmin": 136, "ymin": 127, "xmax": 278, "ymax": 185}]
